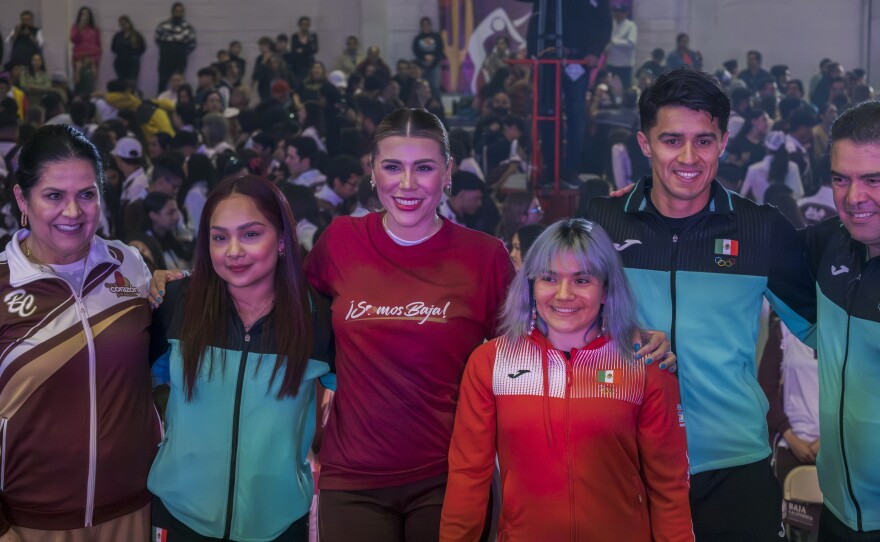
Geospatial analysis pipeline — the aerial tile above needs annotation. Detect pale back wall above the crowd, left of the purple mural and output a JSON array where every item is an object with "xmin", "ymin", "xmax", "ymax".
[{"xmin": 0, "ymin": 0, "xmax": 438, "ymax": 94}]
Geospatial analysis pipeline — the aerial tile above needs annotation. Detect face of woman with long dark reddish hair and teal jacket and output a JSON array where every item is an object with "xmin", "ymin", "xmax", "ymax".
[{"xmin": 208, "ymin": 194, "xmax": 284, "ymax": 295}]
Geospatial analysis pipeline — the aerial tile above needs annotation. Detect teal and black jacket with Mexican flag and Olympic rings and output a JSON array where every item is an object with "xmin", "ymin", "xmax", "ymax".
[{"xmin": 588, "ymin": 177, "xmax": 816, "ymax": 474}]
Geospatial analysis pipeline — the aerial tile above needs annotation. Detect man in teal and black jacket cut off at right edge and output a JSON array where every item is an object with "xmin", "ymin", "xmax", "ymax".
[{"xmin": 804, "ymin": 102, "xmax": 880, "ymax": 542}]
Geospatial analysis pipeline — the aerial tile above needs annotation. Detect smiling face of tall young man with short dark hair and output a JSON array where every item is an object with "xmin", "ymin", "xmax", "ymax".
[{"xmin": 638, "ymin": 106, "xmax": 728, "ymax": 218}]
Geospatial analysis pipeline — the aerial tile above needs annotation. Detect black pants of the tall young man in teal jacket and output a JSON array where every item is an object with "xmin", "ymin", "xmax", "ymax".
[{"xmin": 690, "ymin": 459, "xmax": 785, "ymax": 542}]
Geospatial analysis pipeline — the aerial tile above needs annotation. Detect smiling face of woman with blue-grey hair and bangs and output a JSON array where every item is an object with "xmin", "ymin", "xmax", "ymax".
[{"xmin": 535, "ymin": 252, "xmax": 606, "ymax": 350}]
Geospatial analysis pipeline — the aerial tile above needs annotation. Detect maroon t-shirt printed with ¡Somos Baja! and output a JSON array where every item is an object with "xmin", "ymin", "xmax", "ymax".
[{"xmin": 305, "ymin": 213, "xmax": 513, "ymax": 490}]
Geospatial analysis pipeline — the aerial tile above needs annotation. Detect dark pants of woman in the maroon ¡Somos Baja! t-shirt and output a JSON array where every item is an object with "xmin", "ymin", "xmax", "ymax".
[{"xmin": 318, "ymin": 474, "xmax": 446, "ymax": 542}]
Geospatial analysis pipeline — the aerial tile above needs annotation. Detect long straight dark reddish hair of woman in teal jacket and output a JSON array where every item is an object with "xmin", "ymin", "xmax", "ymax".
[{"xmin": 181, "ymin": 175, "xmax": 312, "ymax": 401}]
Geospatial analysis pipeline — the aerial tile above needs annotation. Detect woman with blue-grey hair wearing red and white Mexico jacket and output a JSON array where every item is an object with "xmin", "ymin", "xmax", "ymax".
[{"xmin": 440, "ymin": 218, "xmax": 694, "ymax": 542}]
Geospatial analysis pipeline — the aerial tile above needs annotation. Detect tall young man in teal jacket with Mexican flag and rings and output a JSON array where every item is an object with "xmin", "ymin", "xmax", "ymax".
[{"xmin": 588, "ymin": 69, "xmax": 815, "ymax": 542}]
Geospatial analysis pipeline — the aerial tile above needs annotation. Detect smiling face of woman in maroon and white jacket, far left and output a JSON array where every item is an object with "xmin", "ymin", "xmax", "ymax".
[{"xmin": 14, "ymin": 160, "xmax": 101, "ymax": 264}]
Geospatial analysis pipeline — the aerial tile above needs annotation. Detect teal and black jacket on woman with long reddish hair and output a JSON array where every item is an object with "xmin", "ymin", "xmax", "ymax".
[{"xmin": 147, "ymin": 281, "xmax": 336, "ymax": 542}]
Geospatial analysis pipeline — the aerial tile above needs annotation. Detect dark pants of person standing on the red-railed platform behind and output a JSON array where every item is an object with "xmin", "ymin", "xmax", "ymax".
[{"xmin": 538, "ymin": 59, "xmax": 590, "ymax": 184}]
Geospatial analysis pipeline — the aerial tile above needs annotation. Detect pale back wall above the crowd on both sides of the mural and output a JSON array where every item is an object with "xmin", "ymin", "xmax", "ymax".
[{"xmin": 0, "ymin": 0, "xmax": 868, "ymax": 93}]
